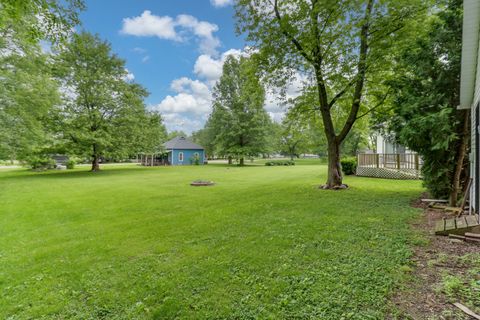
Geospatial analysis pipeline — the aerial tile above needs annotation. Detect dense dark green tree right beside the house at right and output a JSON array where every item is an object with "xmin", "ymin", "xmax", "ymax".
[{"xmin": 388, "ymin": 0, "xmax": 470, "ymax": 205}]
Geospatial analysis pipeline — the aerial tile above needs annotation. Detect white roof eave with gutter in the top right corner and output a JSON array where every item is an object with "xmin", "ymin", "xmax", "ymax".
[{"xmin": 458, "ymin": 0, "xmax": 480, "ymax": 109}]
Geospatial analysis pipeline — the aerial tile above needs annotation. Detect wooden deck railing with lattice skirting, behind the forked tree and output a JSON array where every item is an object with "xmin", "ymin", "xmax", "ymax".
[{"xmin": 357, "ymin": 153, "xmax": 422, "ymax": 179}]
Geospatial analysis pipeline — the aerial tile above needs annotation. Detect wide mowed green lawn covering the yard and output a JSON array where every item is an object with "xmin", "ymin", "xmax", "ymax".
[{"xmin": 0, "ymin": 164, "xmax": 422, "ymax": 319}]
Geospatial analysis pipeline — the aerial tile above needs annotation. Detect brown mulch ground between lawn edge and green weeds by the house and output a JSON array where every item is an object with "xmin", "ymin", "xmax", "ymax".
[{"xmin": 388, "ymin": 195, "xmax": 480, "ymax": 320}]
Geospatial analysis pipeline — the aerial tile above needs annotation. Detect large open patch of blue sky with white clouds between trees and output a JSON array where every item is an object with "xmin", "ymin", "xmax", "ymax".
[{"xmin": 81, "ymin": 0, "xmax": 245, "ymax": 133}]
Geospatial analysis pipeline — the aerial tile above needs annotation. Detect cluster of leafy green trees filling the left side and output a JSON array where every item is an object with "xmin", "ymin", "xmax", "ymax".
[{"xmin": 0, "ymin": 0, "xmax": 166, "ymax": 171}]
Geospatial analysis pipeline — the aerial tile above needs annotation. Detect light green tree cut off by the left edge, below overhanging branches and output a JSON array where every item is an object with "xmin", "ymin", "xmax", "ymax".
[{"xmin": 0, "ymin": 50, "xmax": 60, "ymax": 161}]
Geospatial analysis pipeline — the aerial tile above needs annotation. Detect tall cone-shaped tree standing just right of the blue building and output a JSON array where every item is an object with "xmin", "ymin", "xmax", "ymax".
[{"xmin": 209, "ymin": 56, "xmax": 270, "ymax": 165}]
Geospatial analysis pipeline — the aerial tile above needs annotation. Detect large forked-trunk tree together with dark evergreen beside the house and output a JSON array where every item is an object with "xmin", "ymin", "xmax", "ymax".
[{"xmin": 229, "ymin": 0, "xmax": 469, "ymax": 200}]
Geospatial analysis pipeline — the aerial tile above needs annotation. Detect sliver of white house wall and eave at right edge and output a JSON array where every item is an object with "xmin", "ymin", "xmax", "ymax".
[{"xmin": 459, "ymin": 0, "xmax": 480, "ymax": 212}]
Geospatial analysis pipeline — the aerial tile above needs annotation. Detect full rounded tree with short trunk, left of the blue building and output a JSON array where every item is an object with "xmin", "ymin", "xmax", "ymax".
[{"xmin": 56, "ymin": 32, "xmax": 147, "ymax": 171}]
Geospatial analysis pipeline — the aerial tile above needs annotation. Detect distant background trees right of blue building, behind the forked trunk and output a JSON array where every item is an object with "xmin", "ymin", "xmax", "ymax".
[{"xmin": 192, "ymin": 55, "xmax": 368, "ymax": 165}]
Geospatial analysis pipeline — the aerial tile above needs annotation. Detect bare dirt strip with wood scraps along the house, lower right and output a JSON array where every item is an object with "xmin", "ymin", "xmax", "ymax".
[{"xmin": 388, "ymin": 199, "xmax": 480, "ymax": 320}]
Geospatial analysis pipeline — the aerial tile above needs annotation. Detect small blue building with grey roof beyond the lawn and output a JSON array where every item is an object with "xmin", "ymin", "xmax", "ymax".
[{"xmin": 165, "ymin": 137, "xmax": 206, "ymax": 166}]
